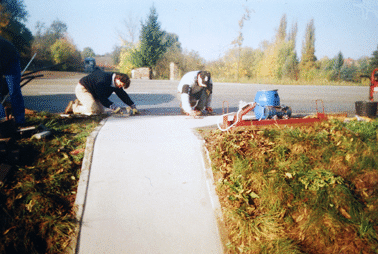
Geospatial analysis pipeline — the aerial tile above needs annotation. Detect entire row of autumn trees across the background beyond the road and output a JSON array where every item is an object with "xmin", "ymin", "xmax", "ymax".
[{"xmin": 0, "ymin": 0, "xmax": 378, "ymax": 83}]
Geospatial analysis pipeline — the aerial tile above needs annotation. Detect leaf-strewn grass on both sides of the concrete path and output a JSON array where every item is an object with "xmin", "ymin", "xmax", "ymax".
[{"xmin": 0, "ymin": 108, "xmax": 378, "ymax": 253}]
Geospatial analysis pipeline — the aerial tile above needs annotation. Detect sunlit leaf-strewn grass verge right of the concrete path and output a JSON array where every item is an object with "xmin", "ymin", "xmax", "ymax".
[{"xmin": 203, "ymin": 120, "xmax": 378, "ymax": 253}]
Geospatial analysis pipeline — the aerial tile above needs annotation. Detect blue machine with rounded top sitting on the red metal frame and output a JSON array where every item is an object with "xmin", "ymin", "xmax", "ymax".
[{"xmin": 254, "ymin": 89, "xmax": 291, "ymax": 119}]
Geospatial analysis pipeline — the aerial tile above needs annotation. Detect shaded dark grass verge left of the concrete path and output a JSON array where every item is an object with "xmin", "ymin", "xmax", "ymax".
[{"xmin": 0, "ymin": 113, "xmax": 103, "ymax": 253}]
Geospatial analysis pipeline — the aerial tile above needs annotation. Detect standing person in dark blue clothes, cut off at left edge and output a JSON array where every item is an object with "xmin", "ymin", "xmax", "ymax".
[{"xmin": 0, "ymin": 37, "xmax": 25, "ymax": 125}]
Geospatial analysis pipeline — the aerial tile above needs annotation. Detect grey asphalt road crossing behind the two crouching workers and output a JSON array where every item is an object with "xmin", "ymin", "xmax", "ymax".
[{"xmin": 22, "ymin": 74, "xmax": 369, "ymax": 116}]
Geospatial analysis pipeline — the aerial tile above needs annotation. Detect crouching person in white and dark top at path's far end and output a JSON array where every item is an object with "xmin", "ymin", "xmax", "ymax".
[{"xmin": 178, "ymin": 71, "xmax": 213, "ymax": 116}]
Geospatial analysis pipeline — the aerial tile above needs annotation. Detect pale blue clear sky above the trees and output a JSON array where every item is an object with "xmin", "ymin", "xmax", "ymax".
[{"xmin": 24, "ymin": 0, "xmax": 378, "ymax": 61}]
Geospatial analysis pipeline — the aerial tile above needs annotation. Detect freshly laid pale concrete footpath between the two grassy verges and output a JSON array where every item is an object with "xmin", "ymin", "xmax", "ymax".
[{"xmin": 74, "ymin": 115, "xmax": 223, "ymax": 254}]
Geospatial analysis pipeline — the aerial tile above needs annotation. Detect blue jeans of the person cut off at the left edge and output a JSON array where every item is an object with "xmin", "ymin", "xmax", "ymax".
[{"xmin": 0, "ymin": 61, "xmax": 25, "ymax": 124}]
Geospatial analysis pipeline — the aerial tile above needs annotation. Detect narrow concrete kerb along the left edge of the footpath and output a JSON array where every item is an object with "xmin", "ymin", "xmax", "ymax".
[{"xmin": 66, "ymin": 117, "xmax": 108, "ymax": 254}]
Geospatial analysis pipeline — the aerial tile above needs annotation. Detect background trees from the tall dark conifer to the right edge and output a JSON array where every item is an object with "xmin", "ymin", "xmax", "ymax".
[{"xmin": 119, "ymin": 6, "xmax": 378, "ymax": 84}]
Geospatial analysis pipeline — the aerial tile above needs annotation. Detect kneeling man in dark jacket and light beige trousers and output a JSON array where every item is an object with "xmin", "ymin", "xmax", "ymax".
[{"xmin": 65, "ymin": 69, "xmax": 138, "ymax": 115}]
